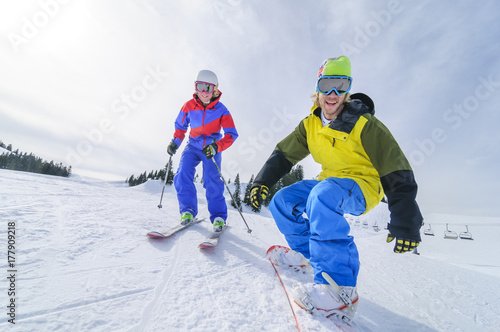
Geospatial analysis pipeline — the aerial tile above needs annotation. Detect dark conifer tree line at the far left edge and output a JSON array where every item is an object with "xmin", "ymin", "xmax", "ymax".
[{"xmin": 0, "ymin": 141, "xmax": 71, "ymax": 178}]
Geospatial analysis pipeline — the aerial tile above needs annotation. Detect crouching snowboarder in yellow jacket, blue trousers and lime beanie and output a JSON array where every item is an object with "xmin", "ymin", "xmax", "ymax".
[{"xmin": 251, "ymin": 56, "xmax": 423, "ymax": 317}]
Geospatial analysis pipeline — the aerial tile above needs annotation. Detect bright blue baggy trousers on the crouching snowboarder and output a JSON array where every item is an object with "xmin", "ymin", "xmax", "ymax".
[{"xmin": 269, "ymin": 178, "xmax": 366, "ymax": 286}]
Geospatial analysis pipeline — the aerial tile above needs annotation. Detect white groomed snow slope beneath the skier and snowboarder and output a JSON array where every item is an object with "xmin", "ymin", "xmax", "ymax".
[{"xmin": 0, "ymin": 170, "xmax": 500, "ymax": 331}]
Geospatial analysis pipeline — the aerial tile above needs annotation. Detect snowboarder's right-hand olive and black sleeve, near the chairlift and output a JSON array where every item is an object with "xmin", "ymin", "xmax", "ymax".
[{"xmin": 361, "ymin": 116, "xmax": 423, "ymax": 241}]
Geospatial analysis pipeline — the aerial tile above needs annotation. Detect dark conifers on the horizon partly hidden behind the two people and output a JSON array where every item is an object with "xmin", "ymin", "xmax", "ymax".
[{"xmin": 125, "ymin": 162, "xmax": 304, "ymax": 212}]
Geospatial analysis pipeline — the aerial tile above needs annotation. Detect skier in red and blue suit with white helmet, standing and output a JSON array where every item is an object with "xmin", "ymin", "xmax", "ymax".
[{"xmin": 167, "ymin": 70, "xmax": 238, "ymax": 231}]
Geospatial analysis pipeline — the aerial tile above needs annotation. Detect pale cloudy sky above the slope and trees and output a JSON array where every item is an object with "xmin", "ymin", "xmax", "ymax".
[{"xmin": 0, "ymin": 0, "xmax": 500, "ymax": 218}]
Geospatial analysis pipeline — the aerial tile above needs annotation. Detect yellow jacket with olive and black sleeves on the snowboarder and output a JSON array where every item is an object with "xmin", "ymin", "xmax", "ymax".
[{"xmin": 254, "ymin": 93, "xmax": 423, "ymax": 240}]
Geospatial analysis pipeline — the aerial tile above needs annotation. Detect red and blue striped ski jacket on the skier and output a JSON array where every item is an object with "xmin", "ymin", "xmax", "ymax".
[{"xmin": 172, "ymin": 93, "xmax": 238, "ymax": 152}]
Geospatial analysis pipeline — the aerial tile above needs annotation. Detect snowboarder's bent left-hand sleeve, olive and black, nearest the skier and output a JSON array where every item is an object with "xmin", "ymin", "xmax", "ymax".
[{"xmin": 253, "ymin": 120, "xmax": 309, "ymax": 188}]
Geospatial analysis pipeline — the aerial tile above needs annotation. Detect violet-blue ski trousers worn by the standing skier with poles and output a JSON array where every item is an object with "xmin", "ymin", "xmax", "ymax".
[{"xmin": 174, "ymin": 144, "xmax": 227, "ymax": 222}]
